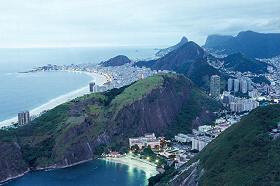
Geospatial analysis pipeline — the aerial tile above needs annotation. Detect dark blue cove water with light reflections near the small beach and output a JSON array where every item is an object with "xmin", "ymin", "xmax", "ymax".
[{"xmin": 6, "ymin": 160, "xmax": 149, "ymax": 186}]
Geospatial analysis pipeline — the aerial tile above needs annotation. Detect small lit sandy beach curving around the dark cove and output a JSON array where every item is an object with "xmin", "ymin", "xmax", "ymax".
[{"xmin": 102, "ymin": 156, "xmax": 158, "ymax": 178}]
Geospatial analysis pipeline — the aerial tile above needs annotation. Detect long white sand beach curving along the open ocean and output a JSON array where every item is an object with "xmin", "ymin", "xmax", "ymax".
[{"xmin": 0, "ymin": 71, "xmax": 107, "ymax": 128}]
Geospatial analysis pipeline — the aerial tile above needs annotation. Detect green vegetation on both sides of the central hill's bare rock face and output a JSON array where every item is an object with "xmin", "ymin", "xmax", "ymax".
[{"xmin": 0, "ymin": 74, "xmax": 219, "ymax": 169}]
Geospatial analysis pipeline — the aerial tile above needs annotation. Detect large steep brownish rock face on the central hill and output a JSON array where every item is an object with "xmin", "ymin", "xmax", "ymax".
[{"xmin": 111, "ymin": 75, "xmax": 193, "ymax": 137}]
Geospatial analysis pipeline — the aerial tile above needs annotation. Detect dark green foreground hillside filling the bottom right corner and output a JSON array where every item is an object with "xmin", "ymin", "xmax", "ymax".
[{"xmin": 153, "ymin": 105, "xmax": 280, "ymax": 186}]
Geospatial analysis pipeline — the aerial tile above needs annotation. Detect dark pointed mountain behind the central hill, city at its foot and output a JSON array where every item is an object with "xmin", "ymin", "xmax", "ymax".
[{"xmin": 135, "ymin": 41, "xmax": 226, "ymax": 90}]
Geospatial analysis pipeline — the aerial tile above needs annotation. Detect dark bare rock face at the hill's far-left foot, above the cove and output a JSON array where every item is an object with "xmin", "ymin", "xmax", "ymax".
[{"xmin": 0, "ymin": 142, "xmax": 29, "ymax": 183}]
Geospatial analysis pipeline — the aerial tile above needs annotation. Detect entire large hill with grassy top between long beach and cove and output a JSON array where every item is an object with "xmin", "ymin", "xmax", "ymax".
[{"xmin": 0, "ymin": 74, "xmax": 221, "ymax": 182}]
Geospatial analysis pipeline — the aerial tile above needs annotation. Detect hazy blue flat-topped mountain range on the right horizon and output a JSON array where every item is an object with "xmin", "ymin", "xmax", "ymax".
[{"xmin": 204, "ymin": 31, "xmax": 280, "ymax": 58}]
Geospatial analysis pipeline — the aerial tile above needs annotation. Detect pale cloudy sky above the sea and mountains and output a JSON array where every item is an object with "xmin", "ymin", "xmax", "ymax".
[{"xmin": 0, "ymin": 0, "xmax": 280, "ymax": 48}]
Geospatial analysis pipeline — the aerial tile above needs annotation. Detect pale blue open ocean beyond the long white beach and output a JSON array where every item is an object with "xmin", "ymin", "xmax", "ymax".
[{"xmin": 0, "ymin": 48, "xmax": 154, "ymax": 121}]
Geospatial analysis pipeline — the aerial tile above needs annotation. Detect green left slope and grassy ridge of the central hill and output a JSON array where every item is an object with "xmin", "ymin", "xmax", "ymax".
[{"xmin": 0, "ymin": 75, "xmax": 166, "ymax": 166}]
